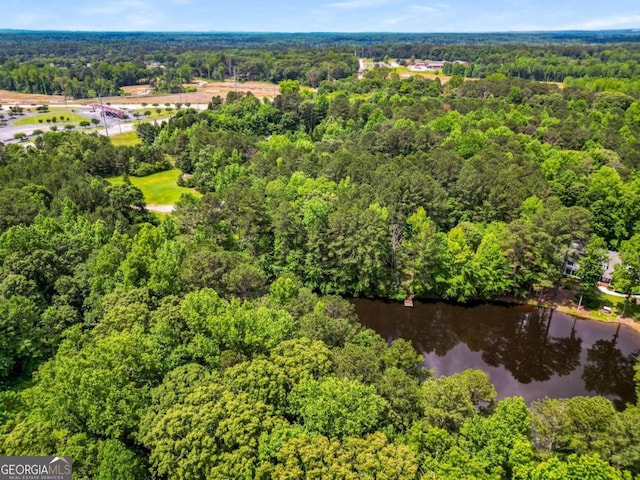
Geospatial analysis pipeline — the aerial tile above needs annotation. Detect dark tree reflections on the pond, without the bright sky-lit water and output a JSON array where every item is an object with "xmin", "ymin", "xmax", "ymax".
[{"xmin": 358, "ymin": 300, "xmax": 640, "ymax": 407}]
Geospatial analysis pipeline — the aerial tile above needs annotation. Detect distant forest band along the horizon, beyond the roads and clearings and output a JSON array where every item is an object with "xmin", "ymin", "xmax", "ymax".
[{"xmin": 0, "ymin": 31, "xmax": 640, "ymax": 98}]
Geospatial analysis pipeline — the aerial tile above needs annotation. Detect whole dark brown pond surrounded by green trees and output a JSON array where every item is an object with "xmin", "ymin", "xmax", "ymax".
[{"xmin": 352, "ymin": 299, "xmax": 640, "ymax": 408}]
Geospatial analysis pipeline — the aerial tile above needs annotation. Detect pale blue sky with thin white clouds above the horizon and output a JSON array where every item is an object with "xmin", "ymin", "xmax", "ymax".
[{"xmin": 0, "ymin": 0, "xmax": 640, "ymax": 32}]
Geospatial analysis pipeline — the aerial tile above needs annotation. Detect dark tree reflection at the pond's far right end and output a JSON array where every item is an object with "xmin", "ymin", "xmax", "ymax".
[{"xmin": 582, "ymin": 325, "xmax": 640, "ymax": 408}]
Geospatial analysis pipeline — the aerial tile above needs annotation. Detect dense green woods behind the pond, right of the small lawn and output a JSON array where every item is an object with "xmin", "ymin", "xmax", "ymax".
[{"xmin": 126, "ymin": 71, "xmax": 640, "ymax": 301}]
